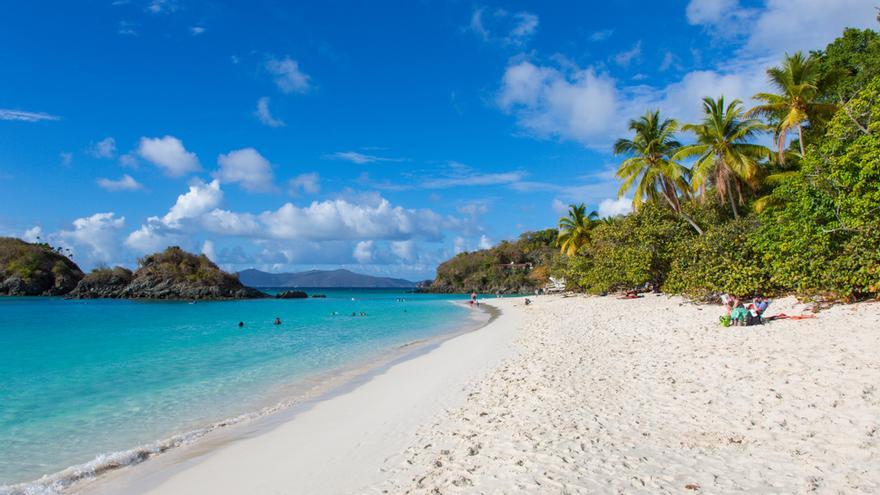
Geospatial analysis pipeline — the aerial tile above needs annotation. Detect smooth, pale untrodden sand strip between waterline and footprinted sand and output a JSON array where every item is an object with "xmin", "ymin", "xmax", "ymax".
[{"xmin": 72, "ymin": 303, "xmax": 518, "ymax": 495}]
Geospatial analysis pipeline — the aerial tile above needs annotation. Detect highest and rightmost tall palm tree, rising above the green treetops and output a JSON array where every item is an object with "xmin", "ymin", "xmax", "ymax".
[{"xmin": 746, "ymin": 52, "xmax": 837, "ymax": 162}]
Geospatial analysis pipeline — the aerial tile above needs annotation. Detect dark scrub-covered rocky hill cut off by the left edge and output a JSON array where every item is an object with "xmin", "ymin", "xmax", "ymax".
[{"xmin": 0, "ymin": 237, "xmax": 83, "ymax": 296}]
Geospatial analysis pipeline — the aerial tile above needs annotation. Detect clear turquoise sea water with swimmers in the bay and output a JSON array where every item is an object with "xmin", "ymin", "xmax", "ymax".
[{"xmin": 0, "ymin": 289, "xmax": 471, "ymax": 492}]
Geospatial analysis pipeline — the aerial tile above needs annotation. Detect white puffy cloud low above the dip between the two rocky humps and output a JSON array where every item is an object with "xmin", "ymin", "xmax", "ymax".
[{"xmin": 57, "ymin": 212, "xmax": 125, "ymax": 263}]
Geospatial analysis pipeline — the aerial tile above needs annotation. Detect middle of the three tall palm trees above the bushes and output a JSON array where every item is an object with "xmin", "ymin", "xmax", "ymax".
[{"xmin": 672, "ymin": 96, "xmax": 771, "ymax": 218}]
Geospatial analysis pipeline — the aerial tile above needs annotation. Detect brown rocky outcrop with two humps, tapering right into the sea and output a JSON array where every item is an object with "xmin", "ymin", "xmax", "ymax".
[{"xmin": 70, "ymin": 246, "xmax": 267, "ymax": 300}]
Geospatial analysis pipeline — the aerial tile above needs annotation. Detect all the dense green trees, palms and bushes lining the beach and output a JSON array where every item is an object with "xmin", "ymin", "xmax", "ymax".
[{"xmin": 435, "ymin": 29, "xmax": 880, "ymax": 301}]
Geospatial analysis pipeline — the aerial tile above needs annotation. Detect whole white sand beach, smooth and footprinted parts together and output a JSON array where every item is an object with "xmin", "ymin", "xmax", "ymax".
[{"xmin": 79, "ymin": 295, "xmax": 880, "ymax": 494}]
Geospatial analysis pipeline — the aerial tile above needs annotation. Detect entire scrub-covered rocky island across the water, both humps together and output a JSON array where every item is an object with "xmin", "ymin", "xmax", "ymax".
[{"xmin": 0, "ymin": 238, "xmax": 268, "ymax": 300}]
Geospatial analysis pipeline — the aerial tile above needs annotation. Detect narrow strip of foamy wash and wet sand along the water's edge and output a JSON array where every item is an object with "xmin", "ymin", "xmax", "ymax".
[{"xmin": 0, "ymin": 301, "xmax": 497, "ymax": 495}]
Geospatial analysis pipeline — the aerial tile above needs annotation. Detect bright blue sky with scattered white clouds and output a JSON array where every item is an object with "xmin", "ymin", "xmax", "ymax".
[{"xmin": 0, "ymin": 0, "xmax": 878, "ymax": 280}]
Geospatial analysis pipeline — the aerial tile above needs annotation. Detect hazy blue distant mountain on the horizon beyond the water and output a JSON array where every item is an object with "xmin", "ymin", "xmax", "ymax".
[{"xmin": 238, "ymin": 268, "xmax": 416, "ymax": 289}]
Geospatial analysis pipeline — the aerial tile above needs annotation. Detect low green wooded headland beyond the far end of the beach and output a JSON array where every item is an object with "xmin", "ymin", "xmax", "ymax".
[{"xmin": 421, "ymin": 229, "xmax": 558, "ymax": 294}]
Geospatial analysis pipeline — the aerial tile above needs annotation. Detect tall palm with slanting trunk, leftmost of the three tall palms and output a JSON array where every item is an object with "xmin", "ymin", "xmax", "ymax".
[{"xmin": 614, "ymin": 110, "xmax": 703, "ymax": 235}]
